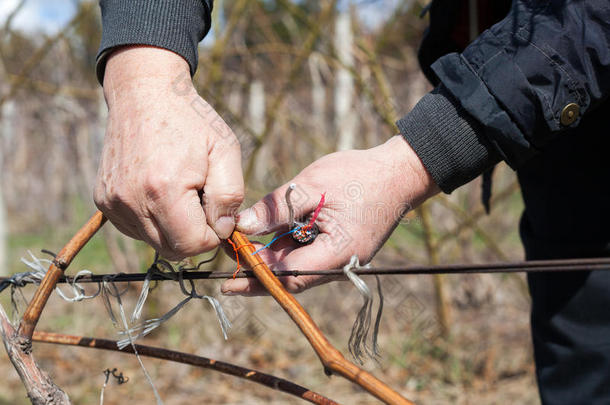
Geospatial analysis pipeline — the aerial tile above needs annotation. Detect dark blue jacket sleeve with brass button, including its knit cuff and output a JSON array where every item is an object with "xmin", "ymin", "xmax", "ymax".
[{"xmin": 398, "ymin": 0, "xmax": 610, "ymax": 192}]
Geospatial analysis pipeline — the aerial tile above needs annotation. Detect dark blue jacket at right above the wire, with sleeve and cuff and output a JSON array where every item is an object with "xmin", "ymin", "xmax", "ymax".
[{"xmin": 398, "ymin": 0, "xmax": 610, "ymax": 258}]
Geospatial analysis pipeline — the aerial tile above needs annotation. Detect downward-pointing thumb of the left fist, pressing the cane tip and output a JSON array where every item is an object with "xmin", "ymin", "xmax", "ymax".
[{"xmin": 203, "ymin": 136, "xmax": 244, "ymax": 239}]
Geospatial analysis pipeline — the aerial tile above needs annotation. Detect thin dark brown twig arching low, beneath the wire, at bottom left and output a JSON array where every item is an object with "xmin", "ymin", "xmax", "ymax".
[{"xmin": 33, "ymin": 332, "xmax": 338, "ymax": 405}]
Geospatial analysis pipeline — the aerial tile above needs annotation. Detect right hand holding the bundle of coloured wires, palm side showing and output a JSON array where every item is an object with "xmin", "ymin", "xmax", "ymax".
[{"xmin": 221, "ymin": 136, "xmax": 439, "ymax": 295}]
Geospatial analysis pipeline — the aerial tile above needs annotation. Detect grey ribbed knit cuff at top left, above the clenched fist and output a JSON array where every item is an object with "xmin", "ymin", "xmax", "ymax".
[{"xmin": 96, "ymin": 0, "xmax": 212, "ymax": 84}]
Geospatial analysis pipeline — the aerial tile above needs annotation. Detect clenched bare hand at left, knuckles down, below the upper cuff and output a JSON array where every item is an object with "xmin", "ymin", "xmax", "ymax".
[{"xmin": 94, "ymin": 46, "xmax": 244, "ymax": 259}]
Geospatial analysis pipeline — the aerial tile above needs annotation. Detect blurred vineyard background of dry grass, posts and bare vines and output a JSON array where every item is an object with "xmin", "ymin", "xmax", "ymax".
[{"xmin": 0, "ymin": 0, "xmax": 538, "ymax": 404}]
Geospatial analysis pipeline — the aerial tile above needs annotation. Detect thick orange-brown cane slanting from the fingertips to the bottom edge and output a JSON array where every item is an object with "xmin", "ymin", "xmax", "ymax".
[{"xmin": 231, "ymin": 231, "xmax": 413, "ymax": 405}]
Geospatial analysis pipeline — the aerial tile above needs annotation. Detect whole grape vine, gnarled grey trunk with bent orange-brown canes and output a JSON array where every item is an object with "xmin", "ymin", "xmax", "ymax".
[{"xmin": 0, "ymin": 211, "xmax": 413, "ymax": 405}]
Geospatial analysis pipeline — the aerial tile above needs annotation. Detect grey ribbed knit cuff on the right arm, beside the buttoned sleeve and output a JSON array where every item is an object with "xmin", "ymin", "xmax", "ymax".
[{"xmin": 396, "ymin": 85, "xmax": 501, "ymax": 193}]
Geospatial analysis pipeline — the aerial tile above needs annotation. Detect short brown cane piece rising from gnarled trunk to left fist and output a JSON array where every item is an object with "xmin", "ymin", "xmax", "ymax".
[{"xmin": 17, "ymin": 211, "xmax": 106, "ymax": 341}]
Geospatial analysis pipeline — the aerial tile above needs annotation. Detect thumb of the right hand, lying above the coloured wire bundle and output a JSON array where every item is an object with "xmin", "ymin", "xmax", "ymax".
[{"xmin": 237, "ymin": 183, "xmax": 319, "ymax": 235}]
